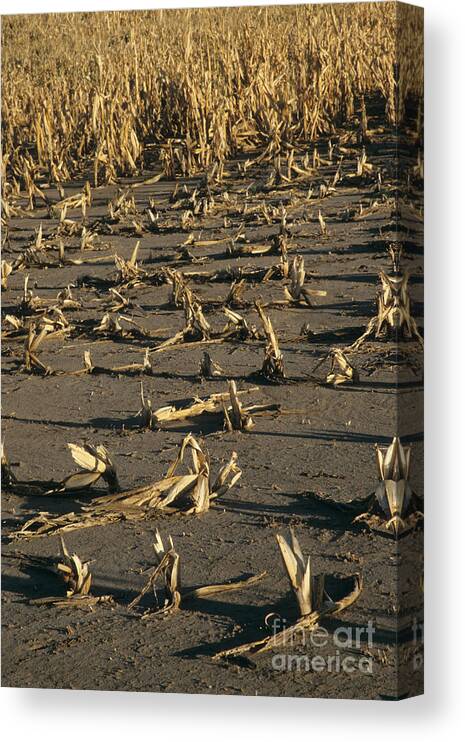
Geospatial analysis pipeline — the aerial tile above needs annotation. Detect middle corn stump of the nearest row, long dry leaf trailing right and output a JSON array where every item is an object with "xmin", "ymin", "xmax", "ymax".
[{"xmin": 128, "ymin": 530, "xmax": 266, "ymax": 620}]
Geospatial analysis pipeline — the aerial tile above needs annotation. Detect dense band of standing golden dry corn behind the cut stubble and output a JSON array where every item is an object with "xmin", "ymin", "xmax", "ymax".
[{"xmin": 2, "ymin": 3, "xmax": 422, "ymax": 185}]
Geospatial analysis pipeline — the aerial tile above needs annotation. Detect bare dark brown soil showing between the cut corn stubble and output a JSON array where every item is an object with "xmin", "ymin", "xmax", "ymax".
[{"xmin": 2, "ymin": 125, "xmax": 423, "ymax": 698}]
